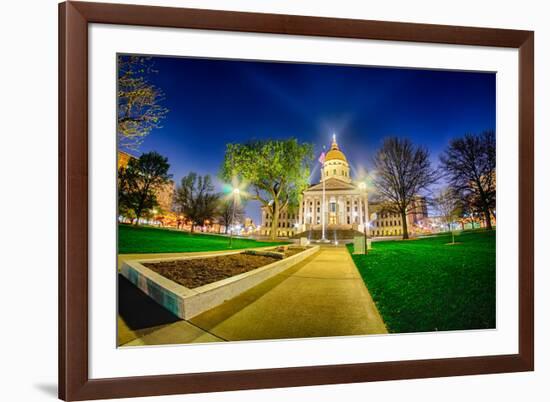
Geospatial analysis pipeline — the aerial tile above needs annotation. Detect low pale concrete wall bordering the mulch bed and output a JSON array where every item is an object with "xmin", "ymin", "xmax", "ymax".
[{"xmin": 120, "ymin": 246, "xmax": 319, "ymax": 319}]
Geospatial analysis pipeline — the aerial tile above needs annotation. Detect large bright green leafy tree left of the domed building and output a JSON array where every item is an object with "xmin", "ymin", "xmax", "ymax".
[{"xmin": 221, "ymin": 138, "xmax": 313, "ymax": 239}]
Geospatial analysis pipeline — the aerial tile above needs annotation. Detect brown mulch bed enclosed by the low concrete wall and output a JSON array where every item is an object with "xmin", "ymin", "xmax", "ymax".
[{"xmin": 143, "ymin": 248, "xmax": 305, "ymax": 289}]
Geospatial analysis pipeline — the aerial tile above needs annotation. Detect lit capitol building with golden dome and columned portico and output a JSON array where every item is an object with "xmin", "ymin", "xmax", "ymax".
[{"xmin": 260, "ymin": 136, "xmax": 427, "ymax": 239}]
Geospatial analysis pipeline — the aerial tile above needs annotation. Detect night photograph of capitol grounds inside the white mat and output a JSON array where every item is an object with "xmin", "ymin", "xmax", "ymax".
[{"xmin": 114, "ymin": 53, "xmax": 497, "ymax": 347}]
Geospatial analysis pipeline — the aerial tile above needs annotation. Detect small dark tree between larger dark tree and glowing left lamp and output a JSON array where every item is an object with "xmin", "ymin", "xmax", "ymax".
[{"xmin": 176, "ymin": 172, "xmax": 220, "ymax": 232}]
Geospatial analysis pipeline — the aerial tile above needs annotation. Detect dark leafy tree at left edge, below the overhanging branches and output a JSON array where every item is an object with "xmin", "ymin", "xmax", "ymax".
[{"xmin": 118, "ymin": 152, "xmax": 172, "ymax": 225}]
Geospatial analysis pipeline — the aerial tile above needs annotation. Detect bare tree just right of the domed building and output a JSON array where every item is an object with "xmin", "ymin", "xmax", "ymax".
[{"xmin": 374, "ymin": 137, "xmax": 438, "ymax": 239}]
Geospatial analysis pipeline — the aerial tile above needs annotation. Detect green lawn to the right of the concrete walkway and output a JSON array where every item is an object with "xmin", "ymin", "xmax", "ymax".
[{"xmin": 348, "ymin": 231, "xmax": 496, "ymax": 333}]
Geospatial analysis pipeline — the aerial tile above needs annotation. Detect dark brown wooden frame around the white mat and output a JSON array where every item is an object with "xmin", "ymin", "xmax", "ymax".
[{"xmin": 59, "ymin": 2, "xmax": 534, "ymax": 400}]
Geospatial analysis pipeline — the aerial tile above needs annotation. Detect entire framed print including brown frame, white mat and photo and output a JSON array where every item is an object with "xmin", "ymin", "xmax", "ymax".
[{"xmin": 59, "ymin": 2, "xmax": 534, "ymax": 400}]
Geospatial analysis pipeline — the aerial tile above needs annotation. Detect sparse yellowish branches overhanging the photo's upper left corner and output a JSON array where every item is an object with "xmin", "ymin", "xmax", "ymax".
[{"xmin": 117, "ymin": 56, "xmax": 168, "ymax": 150}]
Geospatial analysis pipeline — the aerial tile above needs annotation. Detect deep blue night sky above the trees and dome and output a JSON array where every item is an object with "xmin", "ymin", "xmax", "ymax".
[{"xmin": 118, "ymin": 57, "xmax": 496, "ymax": 223}]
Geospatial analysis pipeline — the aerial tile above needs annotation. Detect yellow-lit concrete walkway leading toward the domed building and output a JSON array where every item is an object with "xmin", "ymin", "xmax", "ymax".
[{"xmin": 121, "ymin": 247, "xmax": 387, "ymax": 346}]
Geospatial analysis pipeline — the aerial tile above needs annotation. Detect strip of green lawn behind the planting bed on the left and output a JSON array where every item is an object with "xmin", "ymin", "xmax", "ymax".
[{"xmin": 118, "ymin": 225, "xmax": 286, "ymax": 254}]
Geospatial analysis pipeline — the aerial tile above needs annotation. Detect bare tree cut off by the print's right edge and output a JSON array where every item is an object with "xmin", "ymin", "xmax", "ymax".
[{"xmin": 440, "ymin": 131, "xmax": 496, "ymax": 229}]
